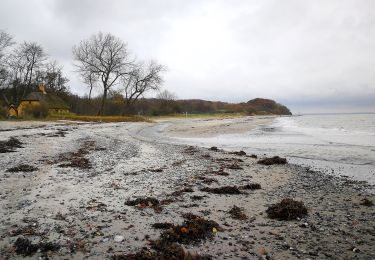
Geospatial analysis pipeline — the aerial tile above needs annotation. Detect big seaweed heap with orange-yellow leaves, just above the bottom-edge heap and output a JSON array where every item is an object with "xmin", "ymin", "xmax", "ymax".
[{"xmin": 161, "ymin": 213, "xmax": 221, "ymax": 244}]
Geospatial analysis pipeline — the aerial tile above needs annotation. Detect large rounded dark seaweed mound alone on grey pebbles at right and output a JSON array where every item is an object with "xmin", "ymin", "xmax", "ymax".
[{"xmin": 266, "ymin": 198, "xmax": 307, "ymax": 220}]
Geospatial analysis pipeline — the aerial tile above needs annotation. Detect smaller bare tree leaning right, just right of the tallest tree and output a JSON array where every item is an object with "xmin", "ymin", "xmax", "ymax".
[{"xmin": 123, "ymin": 61, "xmax": 166, "ymax": 112}]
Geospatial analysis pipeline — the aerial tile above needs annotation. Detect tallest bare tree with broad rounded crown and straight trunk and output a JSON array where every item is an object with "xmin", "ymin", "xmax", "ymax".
[{"xmin": 73, "ymin": 32, "xmax": 133, "ymax": 115}]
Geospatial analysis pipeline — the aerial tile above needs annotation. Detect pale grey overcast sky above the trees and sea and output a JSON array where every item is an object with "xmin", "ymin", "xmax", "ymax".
[{"xmin": 0, "ymin": 0, "xmax": 375, "ymax": 113}]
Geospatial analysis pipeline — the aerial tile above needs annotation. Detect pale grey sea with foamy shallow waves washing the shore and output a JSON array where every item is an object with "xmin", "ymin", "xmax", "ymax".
[{"xmin": 173, "ymin": 114, "xmax": 375, "ymax": 184}]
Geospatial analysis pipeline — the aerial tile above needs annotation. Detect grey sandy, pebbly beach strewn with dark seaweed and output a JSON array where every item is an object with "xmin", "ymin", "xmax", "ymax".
[{"xmin": 0, "ymin": 117, "xmax": 375, "ymax": 259}]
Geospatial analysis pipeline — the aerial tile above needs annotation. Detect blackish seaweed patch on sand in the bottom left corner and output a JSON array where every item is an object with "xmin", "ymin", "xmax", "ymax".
[{"xmin": 13, "ymin": 237, "xmax": 61, "ymax": 256}]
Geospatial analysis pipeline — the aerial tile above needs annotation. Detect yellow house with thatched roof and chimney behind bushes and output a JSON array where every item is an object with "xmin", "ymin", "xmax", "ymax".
[{"xmin": 18, "ymin": 85, "xmax": 69, "ymax": 117}]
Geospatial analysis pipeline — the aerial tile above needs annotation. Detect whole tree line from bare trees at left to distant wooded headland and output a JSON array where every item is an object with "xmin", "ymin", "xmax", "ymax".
[{"xmin": 0, "ymin": 31, "xmax": 290, "ymax": 116}]
